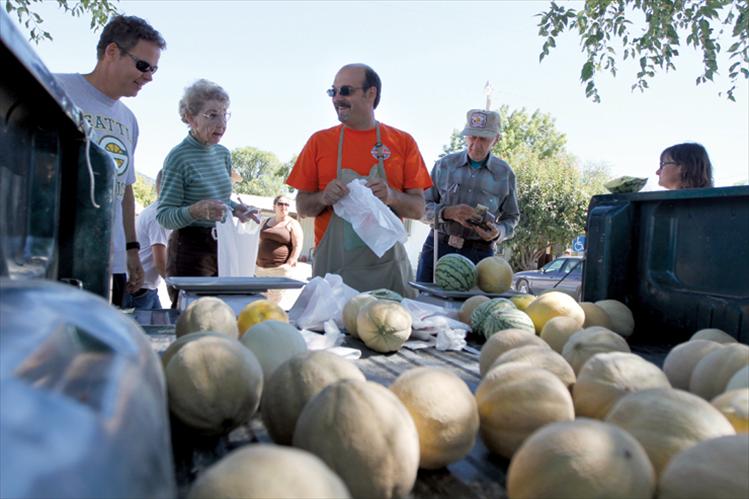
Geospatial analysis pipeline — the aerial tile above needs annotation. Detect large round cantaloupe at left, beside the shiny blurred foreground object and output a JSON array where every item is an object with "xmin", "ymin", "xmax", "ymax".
[{"xmin": 166, "ymin": 335, "xmax": 263, "ymax": 434}]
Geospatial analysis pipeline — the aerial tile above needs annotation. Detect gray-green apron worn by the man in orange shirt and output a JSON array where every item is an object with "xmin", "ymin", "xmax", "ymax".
[{"xmin": 312, "ymin": 123, "xmax": 417, "ymax": 298}]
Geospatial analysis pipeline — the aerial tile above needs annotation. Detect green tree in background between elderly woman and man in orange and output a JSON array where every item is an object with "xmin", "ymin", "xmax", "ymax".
[{"xmin": 231, "ymin": 147, "xmax": 294, "ymax": 196}]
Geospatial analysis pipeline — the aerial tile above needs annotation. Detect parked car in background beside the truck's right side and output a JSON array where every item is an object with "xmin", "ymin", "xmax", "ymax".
[{"xmin": 513, "ymin": 256, "xmax": 584, "ymax": 301}]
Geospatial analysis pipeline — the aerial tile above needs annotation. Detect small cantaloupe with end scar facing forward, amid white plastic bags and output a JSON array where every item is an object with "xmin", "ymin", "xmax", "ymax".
[{"xmin": 356, "ymin": 300, "xmax": 412, "ymax": 353}]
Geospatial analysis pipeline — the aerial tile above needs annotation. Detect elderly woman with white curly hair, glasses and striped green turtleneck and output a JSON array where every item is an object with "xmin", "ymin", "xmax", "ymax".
[{"xmin": 156, "ymin": 80, "xmax": 259, "ymax": 308}]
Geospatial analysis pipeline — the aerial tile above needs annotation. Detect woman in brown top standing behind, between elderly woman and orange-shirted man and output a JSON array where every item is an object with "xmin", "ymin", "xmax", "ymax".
[{"xmin": 255, "ymin": 195, "xmax": 304, "ymax": 303}]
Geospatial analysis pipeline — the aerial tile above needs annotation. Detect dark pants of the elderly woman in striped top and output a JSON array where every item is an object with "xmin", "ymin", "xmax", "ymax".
[{"xmin": 166, "ymin": 227, "xmax": 218, "ymax": 308}]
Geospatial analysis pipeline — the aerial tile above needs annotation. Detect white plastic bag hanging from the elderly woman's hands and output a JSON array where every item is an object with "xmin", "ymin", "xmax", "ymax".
[{"xmin": 214, "ymin": 208, "xmax": 260, "ymax": 277}]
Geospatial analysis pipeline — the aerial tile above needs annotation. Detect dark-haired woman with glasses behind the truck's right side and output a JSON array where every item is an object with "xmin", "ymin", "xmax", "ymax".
[{"xmin": 655, "ymin": 143, "xmax": 713, "ymax": 189}]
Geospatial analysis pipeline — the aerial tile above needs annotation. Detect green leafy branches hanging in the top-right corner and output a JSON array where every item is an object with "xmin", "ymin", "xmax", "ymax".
[{"xmin": 538, "ymin": 0, "xmax": 749, "ymax": 102}]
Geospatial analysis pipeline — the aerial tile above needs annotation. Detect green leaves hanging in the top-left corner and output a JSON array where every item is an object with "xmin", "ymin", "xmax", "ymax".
[{"xmin": 5, "ymin": 0, "xmax": 119, "ymax": 44}]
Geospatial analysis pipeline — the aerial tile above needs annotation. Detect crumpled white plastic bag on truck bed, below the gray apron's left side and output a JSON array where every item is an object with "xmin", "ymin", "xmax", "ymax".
[{"xmin": 289, "ymin": 274, "xmax": 359, "ymax": 331}]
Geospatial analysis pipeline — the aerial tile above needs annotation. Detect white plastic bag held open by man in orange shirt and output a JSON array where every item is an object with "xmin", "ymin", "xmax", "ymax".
[{"xmin": 333, "ymin": 178, "xmax": 408, "ymax": 257}]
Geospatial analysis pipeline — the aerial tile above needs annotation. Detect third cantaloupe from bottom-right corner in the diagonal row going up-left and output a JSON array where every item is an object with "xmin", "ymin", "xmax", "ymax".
[{"xmin": 572, "ymin": 352, "xmax": 671, "ymax": 419}]
